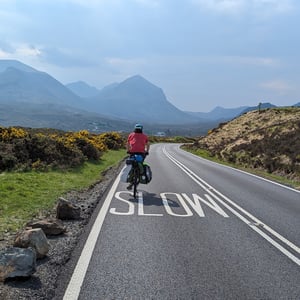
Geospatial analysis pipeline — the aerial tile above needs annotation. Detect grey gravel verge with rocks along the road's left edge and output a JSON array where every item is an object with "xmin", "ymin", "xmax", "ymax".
[{"xmin": 0, "ymin": 164, "xmax": 122, "ymax": 300}]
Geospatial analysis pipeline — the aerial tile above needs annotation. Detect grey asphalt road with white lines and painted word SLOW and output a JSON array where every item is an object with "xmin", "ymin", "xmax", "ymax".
[{"xmin": 64, "ymin": 144, "xmax": 300, "ymax": 300}]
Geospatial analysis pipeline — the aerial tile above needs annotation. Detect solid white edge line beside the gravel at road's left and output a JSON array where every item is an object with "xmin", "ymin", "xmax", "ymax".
[{"xmin": 63, "ymin": 167, "xmax": 125, "ymax": 300}]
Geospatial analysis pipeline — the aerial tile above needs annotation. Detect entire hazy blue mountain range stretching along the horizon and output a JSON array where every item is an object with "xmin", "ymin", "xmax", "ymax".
[{"xmin": 0, "ymin": 60, "xmax": 300, "ymax": 134}]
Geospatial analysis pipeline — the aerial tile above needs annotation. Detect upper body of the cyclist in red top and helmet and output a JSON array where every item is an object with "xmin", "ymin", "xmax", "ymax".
[{"xmin": 126, "ymin": 124, "xmax": 150, "ymax": 190}]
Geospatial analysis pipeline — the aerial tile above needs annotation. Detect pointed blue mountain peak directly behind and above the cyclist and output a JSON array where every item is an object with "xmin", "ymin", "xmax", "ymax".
[{"xmin": 85, "ymin": 75, "xmax": 198, "ymax": 124}]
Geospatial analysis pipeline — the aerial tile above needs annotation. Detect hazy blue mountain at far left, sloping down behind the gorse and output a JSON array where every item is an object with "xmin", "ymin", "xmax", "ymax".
[{"xmin": 0, "ymin": 60, "xmax": 132, "ymax": 132}]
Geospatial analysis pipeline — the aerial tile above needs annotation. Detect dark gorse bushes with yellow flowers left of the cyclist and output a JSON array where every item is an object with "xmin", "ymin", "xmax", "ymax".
[{"xmin": 0, "ymin": 127, "xmax": 124, "ymax": 171}]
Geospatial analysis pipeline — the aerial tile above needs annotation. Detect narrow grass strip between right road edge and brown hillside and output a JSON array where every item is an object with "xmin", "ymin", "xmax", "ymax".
[{"xmin": 182, "ymin": 146, "xmax": 300, "ymax": 190}]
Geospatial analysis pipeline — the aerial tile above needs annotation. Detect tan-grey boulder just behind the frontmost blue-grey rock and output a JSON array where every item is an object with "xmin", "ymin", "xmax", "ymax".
[{"xmin": 14, "ymin": 228, "xmax": 50, "ymax": 258}]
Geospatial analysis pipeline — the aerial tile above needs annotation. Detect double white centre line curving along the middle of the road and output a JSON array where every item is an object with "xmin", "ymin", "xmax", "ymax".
[{"xmin": 163, "ymin": 148, "xmax": 300, "ymax": 266}]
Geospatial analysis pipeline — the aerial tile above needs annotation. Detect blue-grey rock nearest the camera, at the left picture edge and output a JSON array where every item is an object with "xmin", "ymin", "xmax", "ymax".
[{"xmin": 0, "ymin": 247, "xmax": 36, "ymax": 282}]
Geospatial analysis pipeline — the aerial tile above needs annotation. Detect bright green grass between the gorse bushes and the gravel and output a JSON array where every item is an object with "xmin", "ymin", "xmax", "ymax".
[{"xmin": 0, "ymin": 150, "xmax": 126, "ymax": 237}]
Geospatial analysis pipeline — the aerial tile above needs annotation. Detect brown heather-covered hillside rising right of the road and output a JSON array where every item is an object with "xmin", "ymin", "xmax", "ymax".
[{"xmin": 188, "ymin": 107, "xmax": 300, "ymax": 183}]
